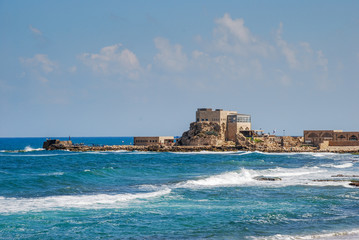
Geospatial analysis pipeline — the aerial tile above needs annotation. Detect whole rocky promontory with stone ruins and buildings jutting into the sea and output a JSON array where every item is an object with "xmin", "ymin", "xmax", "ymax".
[{"xmin": 43, "ymin": 108, "xmax": 359, "ymax": 153}]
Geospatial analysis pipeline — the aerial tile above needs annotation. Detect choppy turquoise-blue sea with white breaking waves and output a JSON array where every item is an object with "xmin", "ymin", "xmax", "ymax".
[{"xmin": 0, "ymin": 137, "xmax": 359, "ymax": 240}]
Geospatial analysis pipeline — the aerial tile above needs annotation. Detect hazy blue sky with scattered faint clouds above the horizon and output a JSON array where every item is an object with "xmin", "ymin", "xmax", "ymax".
[{"xmin": 0, "ymin": 0, "xmax": 359, "ymax": 137}]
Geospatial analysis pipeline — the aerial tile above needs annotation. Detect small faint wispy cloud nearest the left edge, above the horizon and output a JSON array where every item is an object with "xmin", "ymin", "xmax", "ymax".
[{"xmin": 20, "ymin": 54, "xmax": 58, "ymax": 82}]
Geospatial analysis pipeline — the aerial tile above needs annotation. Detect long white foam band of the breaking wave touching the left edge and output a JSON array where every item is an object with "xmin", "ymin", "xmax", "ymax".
[{"xmin": 0, "ymin": 188, "xmax": 171, "ymax": 213}]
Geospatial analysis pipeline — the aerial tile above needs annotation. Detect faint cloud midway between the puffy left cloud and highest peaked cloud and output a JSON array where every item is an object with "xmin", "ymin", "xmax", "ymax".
[{"xmin": 154, "ymin": 37, "xmax": 188, "ymax": 71}]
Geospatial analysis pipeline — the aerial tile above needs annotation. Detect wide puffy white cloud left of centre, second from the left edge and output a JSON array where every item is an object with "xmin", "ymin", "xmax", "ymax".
[{"xmin": 79, "ymin": 44, "xmax": 141, "ymax": 79}]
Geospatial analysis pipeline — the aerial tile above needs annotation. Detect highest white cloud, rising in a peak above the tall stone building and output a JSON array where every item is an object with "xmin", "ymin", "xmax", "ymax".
[{"xmin": 213, "ymin": 13, "xmax": 272, "ymax": 56}]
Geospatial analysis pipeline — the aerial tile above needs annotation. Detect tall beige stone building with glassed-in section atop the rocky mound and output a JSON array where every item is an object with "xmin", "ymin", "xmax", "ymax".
[{"xmin": 196, "ymin": 108, "xmax": 252, "ymax": 141}]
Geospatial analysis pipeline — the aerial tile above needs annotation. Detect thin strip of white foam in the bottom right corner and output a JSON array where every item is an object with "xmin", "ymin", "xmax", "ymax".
[{"xmin": 248, "ymin": 229, "xmax": 359, "ymax": 240}]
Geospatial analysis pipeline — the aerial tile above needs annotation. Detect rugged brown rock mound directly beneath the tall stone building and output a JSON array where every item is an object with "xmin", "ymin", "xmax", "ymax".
[{"xmin": 177, "ymin": 122, "xmax": 226, "ymax": 146}]
